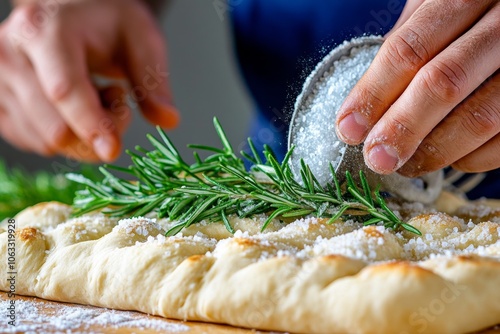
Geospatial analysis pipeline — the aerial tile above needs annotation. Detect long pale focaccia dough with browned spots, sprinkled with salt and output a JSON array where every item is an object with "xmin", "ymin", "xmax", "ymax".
[{"xmin": 0, "ymin": 202, "xmax": 500, "ymax": 333}]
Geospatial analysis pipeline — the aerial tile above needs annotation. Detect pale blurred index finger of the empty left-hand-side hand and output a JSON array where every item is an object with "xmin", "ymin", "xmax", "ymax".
[{"xmin": 10, "ymin": 7, "xmax": 120, "ymax": 161}]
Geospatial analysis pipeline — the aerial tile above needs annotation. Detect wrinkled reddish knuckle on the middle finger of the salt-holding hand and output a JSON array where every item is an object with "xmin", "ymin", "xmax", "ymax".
[{"xmin": 417, "ymin": 60, "xmax": 467, "ymax": 103}]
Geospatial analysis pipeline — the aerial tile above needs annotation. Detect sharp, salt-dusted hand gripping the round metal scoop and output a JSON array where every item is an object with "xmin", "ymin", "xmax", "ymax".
[{"xmin": 336, "ymin": 0, "xmax": 500, "ymax": 177}]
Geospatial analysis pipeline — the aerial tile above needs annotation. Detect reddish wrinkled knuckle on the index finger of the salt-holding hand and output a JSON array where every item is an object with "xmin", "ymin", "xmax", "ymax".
[{"xmin": 384, "ymin": 27, "xmax": 429, "ymax": 73}]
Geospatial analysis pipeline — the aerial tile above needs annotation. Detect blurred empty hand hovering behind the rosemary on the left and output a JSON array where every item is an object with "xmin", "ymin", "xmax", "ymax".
[{"xmin": 0, "ymin": 0, "xmax": 178, "ymax": 161}]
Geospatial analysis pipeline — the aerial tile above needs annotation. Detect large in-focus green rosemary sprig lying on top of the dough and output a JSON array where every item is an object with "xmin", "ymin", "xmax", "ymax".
[{"xmin": 67, "ymin": 118, "xmax": 420, "ymax": 235}]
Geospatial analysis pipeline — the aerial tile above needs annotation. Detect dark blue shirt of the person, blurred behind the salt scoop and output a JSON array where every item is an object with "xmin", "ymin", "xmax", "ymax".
[{"xmin": 228, "ymin": 0, "xmax": 500, "ymax": 198}]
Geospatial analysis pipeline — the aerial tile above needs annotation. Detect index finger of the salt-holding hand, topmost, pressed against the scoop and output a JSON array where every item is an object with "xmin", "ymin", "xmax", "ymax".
[{"xmin": 336, "ymin": 0, "xmax": 491, "ymax": 145}]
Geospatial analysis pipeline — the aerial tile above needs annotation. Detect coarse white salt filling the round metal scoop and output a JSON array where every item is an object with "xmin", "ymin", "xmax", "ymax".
[{"xmin": 293, "ymin": 41, "xmax": 380, "ymax": 184}]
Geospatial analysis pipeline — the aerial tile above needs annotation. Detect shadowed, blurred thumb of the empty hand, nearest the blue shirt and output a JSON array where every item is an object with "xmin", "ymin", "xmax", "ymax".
[{"xmin": 124, "ymin": 8, "xmax": 179, "ymax": 128}]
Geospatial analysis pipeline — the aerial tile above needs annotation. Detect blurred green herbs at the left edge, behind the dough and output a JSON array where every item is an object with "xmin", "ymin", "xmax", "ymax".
[{"xmin": 0, "ymin": 161, "xmax": 98, "ymax": 221}]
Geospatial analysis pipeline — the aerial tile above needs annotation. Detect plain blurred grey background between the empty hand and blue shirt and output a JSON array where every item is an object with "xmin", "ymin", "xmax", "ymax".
[{"xmin": 0, "ymin": 0, "xmax": 252, "ymax": 171}]
